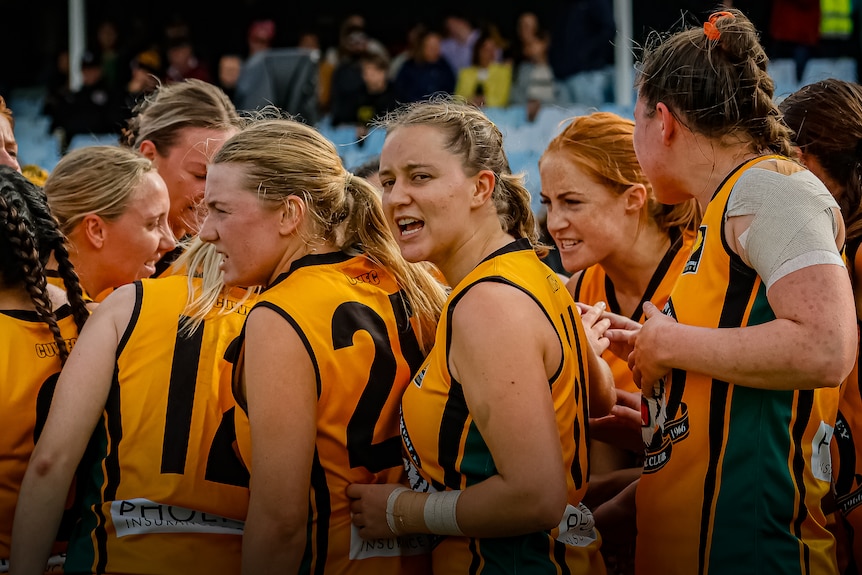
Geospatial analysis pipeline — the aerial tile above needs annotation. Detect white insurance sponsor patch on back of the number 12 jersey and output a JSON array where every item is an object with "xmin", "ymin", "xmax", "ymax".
[{"xmin": 111, "ymin": 499, "xmax": 245, "ymax": 537}]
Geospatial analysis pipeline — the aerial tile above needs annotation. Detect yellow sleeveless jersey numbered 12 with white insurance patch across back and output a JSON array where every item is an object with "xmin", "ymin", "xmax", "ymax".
[{"xmin": 66, "ymin": 276, "xmax": 251, "ymax": 575}]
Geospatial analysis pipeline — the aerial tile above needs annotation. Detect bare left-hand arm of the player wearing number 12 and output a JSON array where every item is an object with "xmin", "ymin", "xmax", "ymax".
[{"xmin": 10, "ymin": 285, "xmax": 135, "ymax": 575}]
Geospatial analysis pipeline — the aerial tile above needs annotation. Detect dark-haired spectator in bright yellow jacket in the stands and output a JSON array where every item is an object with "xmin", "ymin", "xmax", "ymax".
[{"xmin": 455, "ymin": 32, "xmax": 512, "ymax": 108}]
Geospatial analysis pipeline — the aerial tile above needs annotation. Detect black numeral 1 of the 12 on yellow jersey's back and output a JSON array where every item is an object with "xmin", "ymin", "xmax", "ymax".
[{"xmin": 161, "ymin": 322, "xmax": 206, "ymax": 474}]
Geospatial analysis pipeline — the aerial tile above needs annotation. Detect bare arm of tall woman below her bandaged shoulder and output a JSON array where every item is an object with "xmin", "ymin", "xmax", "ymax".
[{"xmin": 629, "ymin": 264, "xmax": 857, "ymax": 389}]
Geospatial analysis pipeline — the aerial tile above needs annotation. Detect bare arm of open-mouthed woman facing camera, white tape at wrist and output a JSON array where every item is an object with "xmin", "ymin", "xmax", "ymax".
[{"xmin": 347, "ymin": 282, "xmax": 580, "ymax": 539}]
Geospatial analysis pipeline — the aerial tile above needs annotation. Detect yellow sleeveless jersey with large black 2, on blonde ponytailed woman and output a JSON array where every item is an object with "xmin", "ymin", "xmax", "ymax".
[{"xmin": 234, "ymin": 252, "xmax": 430, "ymax": 575}]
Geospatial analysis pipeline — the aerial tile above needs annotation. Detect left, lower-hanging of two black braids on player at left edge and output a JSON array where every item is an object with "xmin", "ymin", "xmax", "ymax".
[{"xmin": 0, "ymin": 195, "xmax": 69, "ymax": 362}]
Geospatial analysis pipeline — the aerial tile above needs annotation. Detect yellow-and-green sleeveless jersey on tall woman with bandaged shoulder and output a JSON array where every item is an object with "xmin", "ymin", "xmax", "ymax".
[{"xmin": 636, "ymin": 156, "xmax": 838, "ymax": 575}]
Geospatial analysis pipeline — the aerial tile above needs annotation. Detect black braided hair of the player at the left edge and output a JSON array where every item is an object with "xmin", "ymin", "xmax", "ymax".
[{"xmin": 0, "ymin": 166, "xmax": 89, "ymax": 362}]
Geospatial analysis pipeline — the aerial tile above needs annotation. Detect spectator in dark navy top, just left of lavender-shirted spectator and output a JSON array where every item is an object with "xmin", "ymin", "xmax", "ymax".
[{"xmin": 395, "ymin": 29, "xmax": 456, "ymax": 103}]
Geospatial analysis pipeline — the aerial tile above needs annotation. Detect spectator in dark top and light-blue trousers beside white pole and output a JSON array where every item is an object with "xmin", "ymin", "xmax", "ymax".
[{"xmin": 548, "ymin": 0, "xmax": 616, "ymax": 107}]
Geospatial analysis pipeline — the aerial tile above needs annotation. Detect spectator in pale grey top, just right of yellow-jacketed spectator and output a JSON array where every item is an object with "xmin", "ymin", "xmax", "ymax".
[{"xmin": 510, "ymin": 30, "xmax": 561, "ymax": 122}]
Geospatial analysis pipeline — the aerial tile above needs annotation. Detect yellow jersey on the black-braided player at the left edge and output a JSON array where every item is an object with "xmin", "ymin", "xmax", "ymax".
[{"xmin": 0, "ymin": 305, "xmax": 78, "ymax": 573}]
